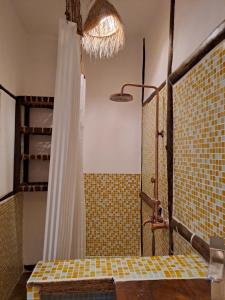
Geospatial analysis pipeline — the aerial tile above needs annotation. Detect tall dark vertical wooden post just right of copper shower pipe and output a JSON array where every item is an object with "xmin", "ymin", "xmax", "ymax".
[{"xmin": 167, "ymin": 0, "xmax": 175, "ymax": 255}]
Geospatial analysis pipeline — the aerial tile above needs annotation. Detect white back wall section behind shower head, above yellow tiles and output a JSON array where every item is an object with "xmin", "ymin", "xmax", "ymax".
[{"xmin": 84, "ymin": 37, "xmax": 142, "ymax": 173}]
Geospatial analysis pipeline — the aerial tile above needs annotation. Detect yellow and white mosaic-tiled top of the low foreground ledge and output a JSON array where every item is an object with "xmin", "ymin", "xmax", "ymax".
[{"xmin": 28, "ymin": 255, "xmax": 208, "ymax": 291}]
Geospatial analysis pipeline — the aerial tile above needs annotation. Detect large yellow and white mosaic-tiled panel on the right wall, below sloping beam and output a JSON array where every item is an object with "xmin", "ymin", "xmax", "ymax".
[{"xmin": 174, "ymin": 41, "xmax": 225, "ymax": 242}]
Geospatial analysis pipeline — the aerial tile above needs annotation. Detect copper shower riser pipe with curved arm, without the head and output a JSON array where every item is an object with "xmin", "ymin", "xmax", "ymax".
[{"xmin": 121, "ymin": 83, "xmax": 160, "ymax": 223}]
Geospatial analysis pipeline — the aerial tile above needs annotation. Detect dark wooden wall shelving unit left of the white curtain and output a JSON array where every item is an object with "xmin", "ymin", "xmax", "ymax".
[{"xmin": 17, "ymin": 96, "xmax": 54, "ymax": 192}]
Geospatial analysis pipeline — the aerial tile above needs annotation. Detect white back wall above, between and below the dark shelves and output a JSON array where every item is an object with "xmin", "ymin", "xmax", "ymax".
[{"xmin": 23, "ymin": 36, "xmax": 57, "ymax": 265}]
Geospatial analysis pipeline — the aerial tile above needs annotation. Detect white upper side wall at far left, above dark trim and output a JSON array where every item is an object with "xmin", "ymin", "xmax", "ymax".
[{"xmin": 0, "ymin": 0, "xmax": 26, "ymax": 94}]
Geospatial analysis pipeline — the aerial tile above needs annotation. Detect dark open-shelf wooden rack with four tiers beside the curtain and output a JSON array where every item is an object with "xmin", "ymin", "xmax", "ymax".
[{"xmin": 16, "ymin": 96, "xmax": 54, "ymax": 192}]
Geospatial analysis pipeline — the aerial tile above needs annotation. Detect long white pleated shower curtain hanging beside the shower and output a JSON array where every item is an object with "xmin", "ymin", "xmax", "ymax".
[{"xmin": 43, "ymin": 20, "xmax": 86, "ymax": 260}]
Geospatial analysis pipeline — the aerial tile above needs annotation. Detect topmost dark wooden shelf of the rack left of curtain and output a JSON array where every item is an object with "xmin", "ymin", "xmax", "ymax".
[{"xmin": 18, "ymin": 96, "xmax": 54, "ymax": 109}]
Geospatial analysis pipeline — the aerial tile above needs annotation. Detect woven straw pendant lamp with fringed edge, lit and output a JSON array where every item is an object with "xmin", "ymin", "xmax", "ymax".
[{"xmin": 82, "ymin": 0, "xmax": 125, "ymax": 58}]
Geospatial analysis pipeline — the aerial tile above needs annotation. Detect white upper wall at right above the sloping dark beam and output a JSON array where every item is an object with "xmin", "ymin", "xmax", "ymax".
[{"xmin": 145, "ymin": 0, "xmax": 225, "ymax": 88}]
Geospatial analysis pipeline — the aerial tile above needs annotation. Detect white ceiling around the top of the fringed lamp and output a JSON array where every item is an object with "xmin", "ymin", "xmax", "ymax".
[{"xmin": 11, "ymin": 0, "xmax": 160, "ymax": 36}]
